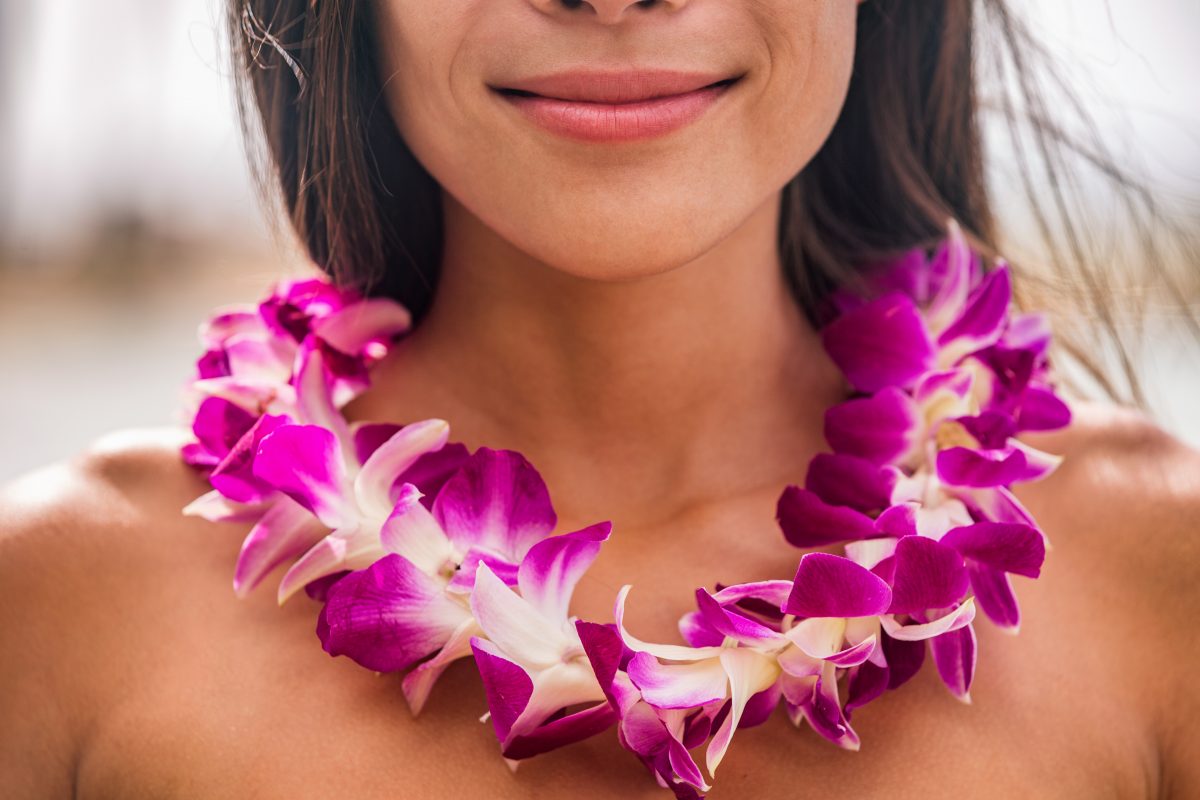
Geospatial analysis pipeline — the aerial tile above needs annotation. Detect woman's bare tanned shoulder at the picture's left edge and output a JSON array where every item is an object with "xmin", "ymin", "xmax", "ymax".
[{"xmin": 0, "ymin": 429, "xmax": 226, "ymax": 798}]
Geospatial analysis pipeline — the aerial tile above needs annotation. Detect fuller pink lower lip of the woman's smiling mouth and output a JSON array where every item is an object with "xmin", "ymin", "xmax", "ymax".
[{"xmin": 500, "ymin": 82, "xmax": 736, "ymax": 142}]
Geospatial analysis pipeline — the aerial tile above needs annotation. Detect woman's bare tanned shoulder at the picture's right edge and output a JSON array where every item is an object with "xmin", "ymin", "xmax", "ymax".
[{"xmin": 1019, "ymin": 403, "xmax": 1200, "ymax": 798}]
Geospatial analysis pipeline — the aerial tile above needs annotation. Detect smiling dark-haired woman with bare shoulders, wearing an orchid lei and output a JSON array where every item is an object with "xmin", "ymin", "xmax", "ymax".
[{"xmin": 0, "ymin": 0, "xmax": 1200, "ymax": 798}]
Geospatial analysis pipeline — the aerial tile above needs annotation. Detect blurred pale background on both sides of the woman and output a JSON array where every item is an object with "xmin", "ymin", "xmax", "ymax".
[{"xmin": 0, "ymin": 0, "xmax": 1200, "ymax": 482}]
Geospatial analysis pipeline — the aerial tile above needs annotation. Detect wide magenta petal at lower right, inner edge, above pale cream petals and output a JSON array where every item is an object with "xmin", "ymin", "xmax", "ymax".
[{"xmin": 784, "ymin": 553, "xmax": 892, "ymax": 616}]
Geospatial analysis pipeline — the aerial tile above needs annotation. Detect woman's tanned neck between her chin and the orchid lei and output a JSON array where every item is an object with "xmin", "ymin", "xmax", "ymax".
[{"xmin": 358, "ymin": 190, "xmax": 842, "ymax": 518}]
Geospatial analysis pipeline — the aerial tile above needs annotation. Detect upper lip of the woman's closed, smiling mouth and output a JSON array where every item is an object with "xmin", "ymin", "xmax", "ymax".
[{"xmin": 492, "ymin": 70, "xmax": 740, "ymax": 103}]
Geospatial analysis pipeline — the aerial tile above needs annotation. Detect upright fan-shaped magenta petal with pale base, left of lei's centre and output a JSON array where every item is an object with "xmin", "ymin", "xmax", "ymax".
[{"xmin": 433, "ymin": 447, "xmax": 557, "ymax": 561}]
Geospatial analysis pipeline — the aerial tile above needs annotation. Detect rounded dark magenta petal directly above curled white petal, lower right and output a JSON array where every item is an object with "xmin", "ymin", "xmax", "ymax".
[{"xmin": 887, "ymin": 536, "xmax": 968, "ymax": 614}]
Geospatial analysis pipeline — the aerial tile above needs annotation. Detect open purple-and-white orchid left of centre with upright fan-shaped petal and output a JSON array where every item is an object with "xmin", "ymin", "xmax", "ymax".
[{"xmin": 319, "ymin": 447, "xmax": 590, "ymax": 714}]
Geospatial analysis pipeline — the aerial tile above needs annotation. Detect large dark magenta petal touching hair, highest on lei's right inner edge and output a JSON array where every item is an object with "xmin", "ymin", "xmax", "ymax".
[{"xmin": 821, "ymin": 294, "xmax": 934, "ymax": 392}]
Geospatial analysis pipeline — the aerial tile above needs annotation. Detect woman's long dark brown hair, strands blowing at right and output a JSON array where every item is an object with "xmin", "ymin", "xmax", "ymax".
[{"xmin": 228, "ymin": 0, "xmax": 1195, "ymax": 403}]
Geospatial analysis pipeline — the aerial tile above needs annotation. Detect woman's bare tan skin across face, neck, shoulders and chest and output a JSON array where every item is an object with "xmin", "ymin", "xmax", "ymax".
[{"xmin": 0, "ymin": 1, "xmax": 1200, "ymax": 800}]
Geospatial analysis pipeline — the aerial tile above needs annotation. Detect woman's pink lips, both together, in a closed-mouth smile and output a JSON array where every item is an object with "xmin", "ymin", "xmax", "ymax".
[{"xmin": 497, "ymin": 71, "xmax": 737, "ymax": 142}]
